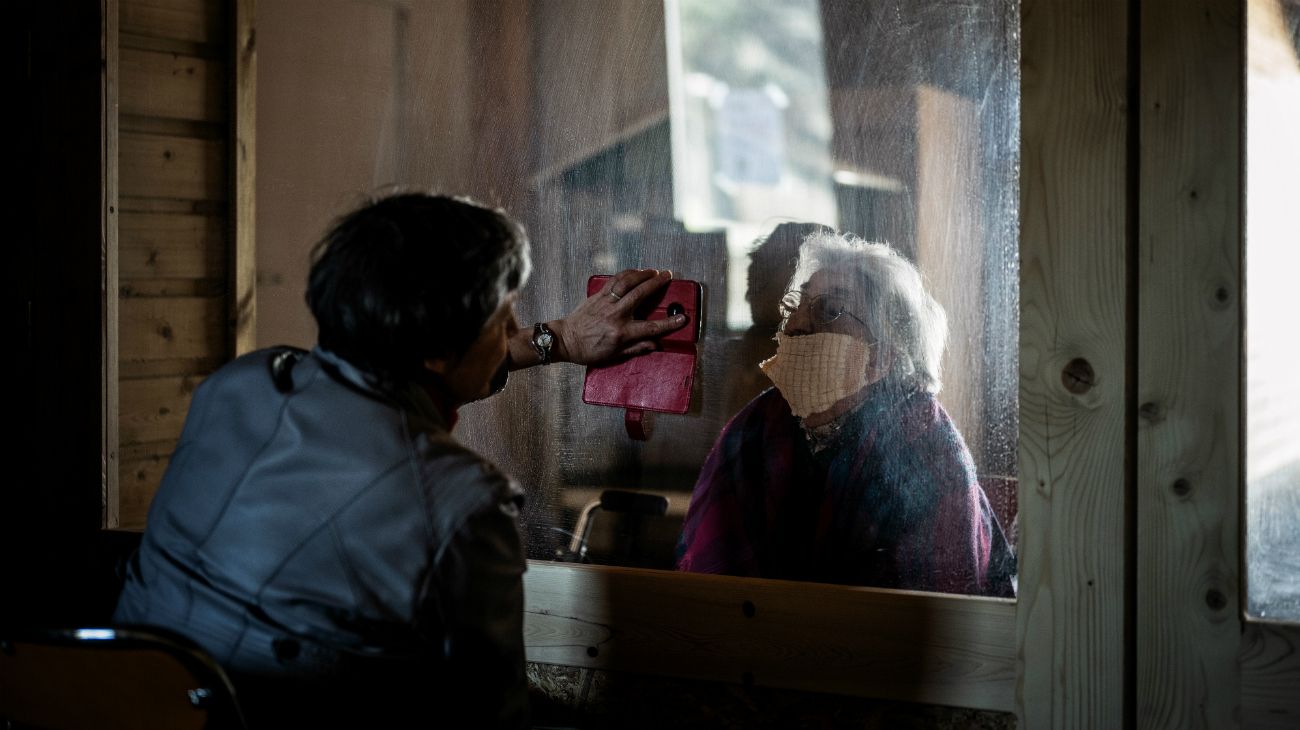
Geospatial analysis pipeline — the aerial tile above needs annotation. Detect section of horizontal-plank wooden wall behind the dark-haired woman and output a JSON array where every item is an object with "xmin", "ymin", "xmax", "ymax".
[{"xmin": 115, "ymin": 0, "xmax": 252, "ymax": 529}]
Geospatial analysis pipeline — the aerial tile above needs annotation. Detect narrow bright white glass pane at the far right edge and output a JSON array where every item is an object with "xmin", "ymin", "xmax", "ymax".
[{"xmin": 1245, "ymin": 0, "xmax": 1300, "ymax": 621}]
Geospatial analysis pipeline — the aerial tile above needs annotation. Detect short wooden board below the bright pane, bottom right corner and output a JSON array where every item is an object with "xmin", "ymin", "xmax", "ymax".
[{"xmin": 1242, "ymin": 621, "xmax": 1300, "ymax": 730}]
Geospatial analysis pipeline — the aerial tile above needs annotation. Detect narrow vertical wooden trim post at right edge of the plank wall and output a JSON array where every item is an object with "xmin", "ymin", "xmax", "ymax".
[{"xmin": 229, "ymin": 0, "xmax": 257, "ymax": 357}]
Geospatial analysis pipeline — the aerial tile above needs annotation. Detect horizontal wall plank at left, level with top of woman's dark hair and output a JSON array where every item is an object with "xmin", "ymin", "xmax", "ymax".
[{"xmin": 118, "ymin": 213, "xmax": 226, "ymax": 279}]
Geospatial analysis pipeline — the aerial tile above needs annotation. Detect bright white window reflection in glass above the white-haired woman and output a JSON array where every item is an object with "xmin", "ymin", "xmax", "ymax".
[{"xmin": 664, "ymin": 0, "xmax": 837, "ymax": 329}]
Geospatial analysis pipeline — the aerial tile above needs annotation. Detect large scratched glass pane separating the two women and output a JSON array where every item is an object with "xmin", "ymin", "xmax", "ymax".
[{"xmin": 257, "ymin": 0, "xmax": 1019, "ymax": 595}]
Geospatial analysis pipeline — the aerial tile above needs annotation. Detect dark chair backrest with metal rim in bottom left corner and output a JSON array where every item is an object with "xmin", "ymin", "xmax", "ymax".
[{"xmin": 0, "ymin": 627, "xmax": 244, "ymax": 730}]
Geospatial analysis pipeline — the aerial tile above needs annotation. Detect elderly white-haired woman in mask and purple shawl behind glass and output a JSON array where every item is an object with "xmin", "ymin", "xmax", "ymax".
[{"xmin": 677, "ymin": 231, "xmax": 1015, "ymax": 596}]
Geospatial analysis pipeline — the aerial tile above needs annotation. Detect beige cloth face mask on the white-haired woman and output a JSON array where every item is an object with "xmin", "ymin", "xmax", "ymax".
[{"xmin": 758, "ymin": 333, "xmax": 871, "ymax": 418}]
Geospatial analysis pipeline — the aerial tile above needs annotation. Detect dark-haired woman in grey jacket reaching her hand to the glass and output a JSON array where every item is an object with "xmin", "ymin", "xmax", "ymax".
[{"xmin": 114, "ymin": 194, "xmax": 685, "ymax": 727}]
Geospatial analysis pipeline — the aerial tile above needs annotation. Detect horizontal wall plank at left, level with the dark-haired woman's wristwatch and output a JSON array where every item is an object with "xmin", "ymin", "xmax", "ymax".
[{"xmin": 121, "ymin": 297, "xmax": 226, "ymax": 361}]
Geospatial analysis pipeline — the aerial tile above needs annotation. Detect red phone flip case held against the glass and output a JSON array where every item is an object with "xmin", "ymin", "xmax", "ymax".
[{"xmin": 582, "ymin": 275, "xmax": 703, "ymax": 440}]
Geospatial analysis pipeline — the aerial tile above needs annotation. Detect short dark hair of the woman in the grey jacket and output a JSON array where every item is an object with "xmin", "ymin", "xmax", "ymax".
[{"xmin": 307, "ymin": 192, "xmax": 530, "ymax": 386}]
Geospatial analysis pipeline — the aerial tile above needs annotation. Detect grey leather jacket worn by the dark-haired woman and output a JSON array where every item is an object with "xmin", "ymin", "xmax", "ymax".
[{"xmin": 114, "ymin": 348, "xmax": 528, "ymax": 726}]
